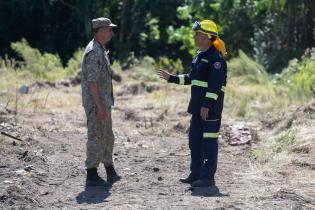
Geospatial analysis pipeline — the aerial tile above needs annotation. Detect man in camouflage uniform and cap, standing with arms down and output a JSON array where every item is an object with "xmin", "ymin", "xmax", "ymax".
[{"xmin": 81, "ymin": 18, "xmax": 121, "ymax": 185}]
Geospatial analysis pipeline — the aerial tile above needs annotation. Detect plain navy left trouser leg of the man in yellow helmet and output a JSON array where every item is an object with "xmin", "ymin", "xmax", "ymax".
[{"xmin": 189, "ymin": 114, "xmax": 203, "ymax": 178}]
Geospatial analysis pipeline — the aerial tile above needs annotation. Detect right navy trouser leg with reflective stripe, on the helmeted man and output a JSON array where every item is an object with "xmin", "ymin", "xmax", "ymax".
[{"xmin": 200, "ymin": 119, "xmax": 221, "ymax": 180}]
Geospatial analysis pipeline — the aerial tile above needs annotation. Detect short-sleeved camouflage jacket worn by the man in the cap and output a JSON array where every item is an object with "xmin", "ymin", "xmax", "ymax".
[{"xmin": 81, "ymin": 39, "xmax": 114, "ymax": 108}]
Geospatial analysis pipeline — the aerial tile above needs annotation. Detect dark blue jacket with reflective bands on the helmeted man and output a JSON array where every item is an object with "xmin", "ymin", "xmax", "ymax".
[{"xmin": 168, "ymin": 46, "xmax": 227, "ymax": 119}]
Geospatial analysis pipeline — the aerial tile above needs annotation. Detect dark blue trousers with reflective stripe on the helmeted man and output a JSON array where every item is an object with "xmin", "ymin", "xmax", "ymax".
[{"xmin": 189, "ymin": 114, "xmax": 221, "ymax": 180}]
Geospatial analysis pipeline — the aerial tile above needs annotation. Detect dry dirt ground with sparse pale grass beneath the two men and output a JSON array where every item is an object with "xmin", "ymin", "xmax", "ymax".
[{"xmin": 0, "ymin": 77, "xmax": 315, "ymax": 210}]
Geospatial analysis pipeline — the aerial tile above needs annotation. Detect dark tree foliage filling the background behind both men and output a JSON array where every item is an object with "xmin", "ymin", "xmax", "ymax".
[{"xmin": 0, "ymin": 0, "xmax": 315, "ymax": 73}]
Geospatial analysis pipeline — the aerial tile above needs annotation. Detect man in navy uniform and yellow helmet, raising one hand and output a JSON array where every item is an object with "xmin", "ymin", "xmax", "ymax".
[{"xmin": 158, "ymin": 20, "xmax": 227, "ymax": 187}]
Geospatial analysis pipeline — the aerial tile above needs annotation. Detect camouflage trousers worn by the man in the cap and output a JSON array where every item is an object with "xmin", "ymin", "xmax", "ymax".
[{"xmin": 85, "ymin": 106, "xmax": 115, "ymax": 168}]
